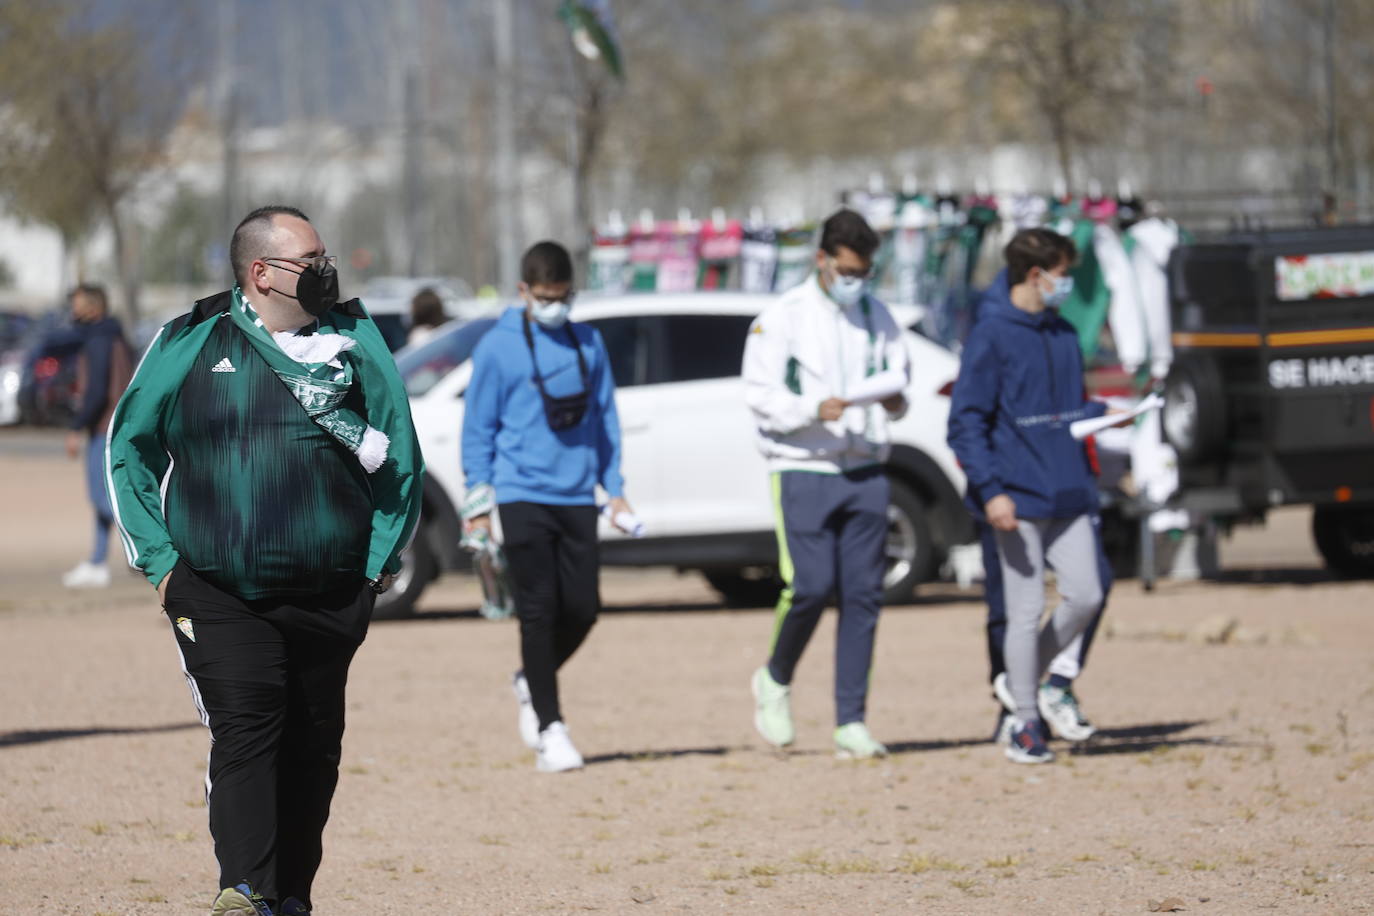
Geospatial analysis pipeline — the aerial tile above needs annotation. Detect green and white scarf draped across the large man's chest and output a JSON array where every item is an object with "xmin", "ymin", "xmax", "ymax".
[{"xmin": 229, "ymin": 288, "xmax": 392, "ymax": 474}]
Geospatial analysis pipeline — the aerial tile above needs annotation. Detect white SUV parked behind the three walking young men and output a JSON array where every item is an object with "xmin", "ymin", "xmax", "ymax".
[{"xmin": 376, "ymin": 293, "xmax": 973, "ymax": 617}]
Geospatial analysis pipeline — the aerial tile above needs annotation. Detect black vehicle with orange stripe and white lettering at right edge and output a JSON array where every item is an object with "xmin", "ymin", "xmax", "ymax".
[{"xmin": 1162, "ymin": 225, "xmax": 1374, "ymax": 575}]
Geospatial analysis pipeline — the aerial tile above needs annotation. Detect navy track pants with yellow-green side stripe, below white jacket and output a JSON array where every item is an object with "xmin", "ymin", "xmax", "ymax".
[{"xmin": 768, "ymin": 467, "xmax": 888, "ymax": 725}]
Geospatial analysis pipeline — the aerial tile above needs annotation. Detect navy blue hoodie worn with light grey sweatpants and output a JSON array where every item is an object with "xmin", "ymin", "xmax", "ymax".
[{"xmin": 948, "ymin": 271, "xmax": 1106, "ymax": 519}]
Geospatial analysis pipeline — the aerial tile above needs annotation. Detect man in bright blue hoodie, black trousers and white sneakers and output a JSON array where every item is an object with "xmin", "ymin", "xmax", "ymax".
[{"xmin": 463, "ymin": 242, "xmax": 631, "ymax": 773}]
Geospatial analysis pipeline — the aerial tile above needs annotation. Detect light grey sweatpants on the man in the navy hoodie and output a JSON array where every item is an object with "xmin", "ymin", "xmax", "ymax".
[{"xmin": 996, "ymin": 515, "xmax": 1102, "ymax": 720}]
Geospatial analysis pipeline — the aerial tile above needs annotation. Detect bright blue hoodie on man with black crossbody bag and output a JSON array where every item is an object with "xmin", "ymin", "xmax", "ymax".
[{"xmin": 463, "ymin": 308, "xmax": 625, "ymax": 505}]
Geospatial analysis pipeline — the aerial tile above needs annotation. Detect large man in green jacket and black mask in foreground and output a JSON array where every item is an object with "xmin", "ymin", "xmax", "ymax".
[{"xmin": 106, "ymin": 206, "xmax": 423, "ymax": 916}]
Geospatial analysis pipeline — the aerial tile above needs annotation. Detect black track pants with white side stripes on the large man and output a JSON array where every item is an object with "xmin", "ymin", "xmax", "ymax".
[{"xmin": 165, "ymin": 562, "xmax": 375, "ymax": 906}]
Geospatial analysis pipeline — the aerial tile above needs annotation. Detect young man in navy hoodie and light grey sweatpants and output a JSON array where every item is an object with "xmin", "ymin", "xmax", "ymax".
[{"xmin": 948, "ymin": 229, "xmax": 1106, "ymax": 764}]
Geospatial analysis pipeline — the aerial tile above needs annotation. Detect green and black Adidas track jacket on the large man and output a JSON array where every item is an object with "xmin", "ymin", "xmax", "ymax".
[{"xmin": 106, "ymin": 291, "xmax": 423, "ymax": 600}]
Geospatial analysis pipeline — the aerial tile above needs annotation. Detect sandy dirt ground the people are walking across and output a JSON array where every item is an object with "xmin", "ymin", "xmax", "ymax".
[{"xmin": 0, "ymin": 431, "xmax": 1374, "ymax": 916}]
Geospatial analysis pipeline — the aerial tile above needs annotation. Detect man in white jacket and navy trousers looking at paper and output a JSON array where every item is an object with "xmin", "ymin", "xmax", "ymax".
[{"xmin": 743, "ymin": 210, "xmax": 910, "ymax": 758}]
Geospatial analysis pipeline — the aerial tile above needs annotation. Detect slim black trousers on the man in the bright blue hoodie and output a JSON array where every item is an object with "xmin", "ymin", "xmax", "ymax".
[{"xmin": 497, "ymin": 503, "xmax": 600, "ymax": 731}]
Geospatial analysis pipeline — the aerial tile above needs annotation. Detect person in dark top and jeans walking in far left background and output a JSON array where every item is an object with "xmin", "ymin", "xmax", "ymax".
[{"xmin": 47, "ymin": 284, "xmax": 133, "ymax": 588}]
